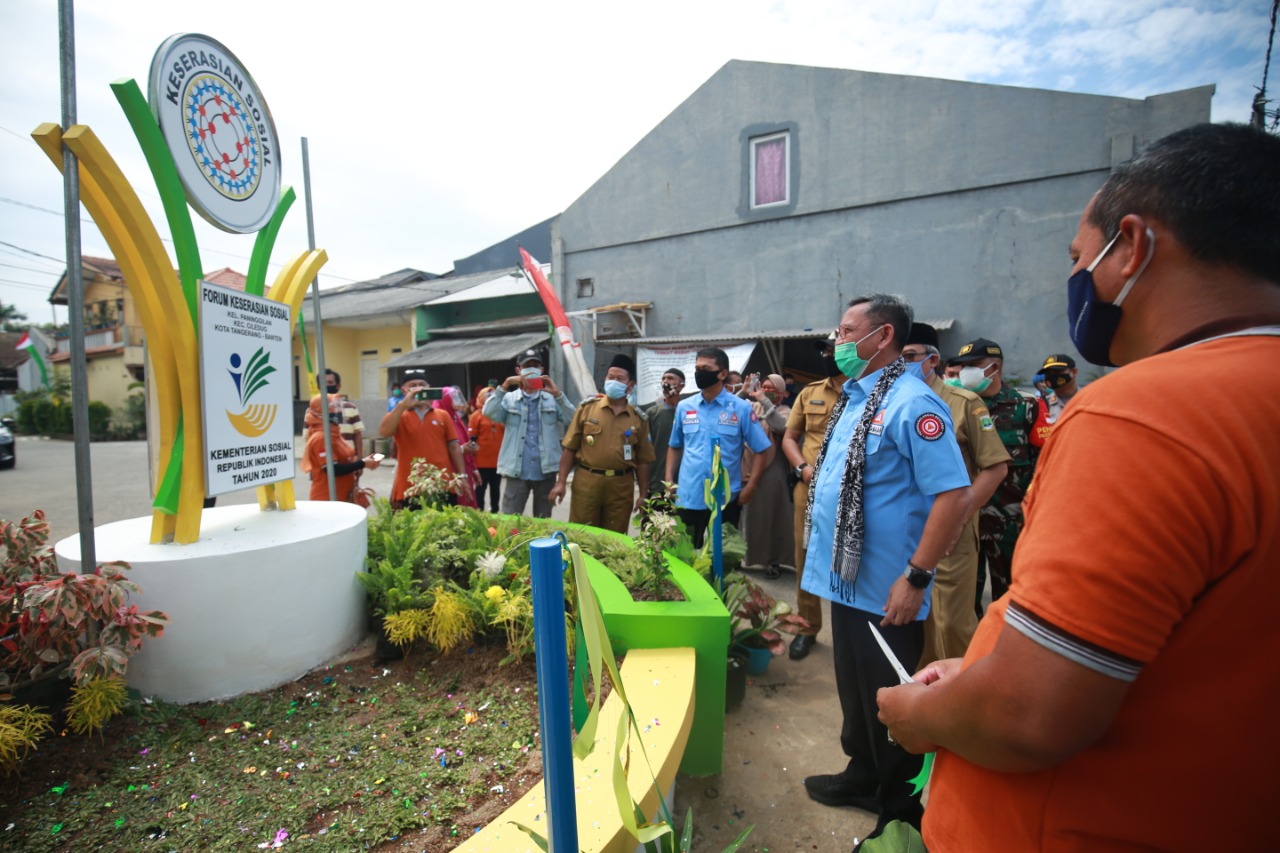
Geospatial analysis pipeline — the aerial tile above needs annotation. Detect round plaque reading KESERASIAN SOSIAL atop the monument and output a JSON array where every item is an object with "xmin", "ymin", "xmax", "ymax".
[{"xmin": 150, "ymin": 33, "xmax": 280, "ymax": 234}]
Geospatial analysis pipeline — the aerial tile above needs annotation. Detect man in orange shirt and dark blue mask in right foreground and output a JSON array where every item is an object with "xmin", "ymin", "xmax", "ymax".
[{"xmin": 878, "ymin": 124, "xmax": 1280, "ymax": 853}]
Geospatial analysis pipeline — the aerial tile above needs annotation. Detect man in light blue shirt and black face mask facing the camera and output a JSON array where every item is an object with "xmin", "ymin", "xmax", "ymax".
[{"xmin": 667, "ymin": 347, "xmax": 772, "ymax": 548}]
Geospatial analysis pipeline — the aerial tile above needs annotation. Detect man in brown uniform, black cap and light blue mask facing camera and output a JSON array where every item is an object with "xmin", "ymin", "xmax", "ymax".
[{"xmin": 550, "ymin": 353, "xmax": 654, "ymax": 533}]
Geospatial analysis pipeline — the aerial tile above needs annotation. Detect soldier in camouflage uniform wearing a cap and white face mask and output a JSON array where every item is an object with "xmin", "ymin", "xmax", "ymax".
[{"xmin": 947, "ymin": 338, "xmax": 1039, "ymax": 616}]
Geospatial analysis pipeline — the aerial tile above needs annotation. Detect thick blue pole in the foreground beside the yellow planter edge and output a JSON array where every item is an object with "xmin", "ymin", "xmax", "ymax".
[{"xmin": 529, "ymin": 539, "xmax": 577, "ymax": 853}]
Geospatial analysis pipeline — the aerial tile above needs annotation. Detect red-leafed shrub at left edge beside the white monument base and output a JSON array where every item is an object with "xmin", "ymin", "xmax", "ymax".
[{"xmin": 0, "ymin": 510, "xmax": 169, "ymax": 689}]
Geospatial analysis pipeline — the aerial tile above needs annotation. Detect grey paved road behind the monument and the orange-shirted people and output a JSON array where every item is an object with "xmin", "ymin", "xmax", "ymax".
[{"xmin": 0, "ymin": 437, "xmax": 568, "ymax": 540}]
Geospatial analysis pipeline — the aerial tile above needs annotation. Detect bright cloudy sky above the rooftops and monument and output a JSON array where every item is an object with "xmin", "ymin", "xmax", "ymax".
[{"xmin": 0, "ymin": 0, "xmax": 1264, "ymax": 321}]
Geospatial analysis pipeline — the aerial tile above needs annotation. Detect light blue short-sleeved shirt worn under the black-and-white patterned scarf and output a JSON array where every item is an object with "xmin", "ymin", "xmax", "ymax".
[{"xmin": 801, "ymin": 370, "xmax": 969, "ymax": 619}]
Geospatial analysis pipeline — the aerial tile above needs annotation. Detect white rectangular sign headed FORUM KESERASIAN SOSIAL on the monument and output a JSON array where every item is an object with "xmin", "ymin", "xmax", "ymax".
[{"xmin": 200, "ymin": 282, "xmax": 293, "ymax": 496}]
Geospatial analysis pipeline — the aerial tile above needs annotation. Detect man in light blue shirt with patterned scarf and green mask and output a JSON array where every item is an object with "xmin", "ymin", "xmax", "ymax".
[{"xmin": 803, "ymin": 293, "xmax": 969, "ymax": 838}]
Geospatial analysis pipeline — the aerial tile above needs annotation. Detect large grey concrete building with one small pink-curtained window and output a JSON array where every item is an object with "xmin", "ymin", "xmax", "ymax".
[{"xmin": 552, "ymin": 60, "xmax": 1213, "ymax": 389}]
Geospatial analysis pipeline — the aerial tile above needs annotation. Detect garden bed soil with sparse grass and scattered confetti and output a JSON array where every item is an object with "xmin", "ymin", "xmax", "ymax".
[{"xmin": 0, "ymin": 646, "xmax": 541, "ymax": 853}]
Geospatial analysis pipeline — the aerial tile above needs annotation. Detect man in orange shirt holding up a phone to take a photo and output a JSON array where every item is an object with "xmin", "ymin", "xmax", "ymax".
[{"xmin": 378, "ymin": 371, "xmax": 471, "ymax": 510}]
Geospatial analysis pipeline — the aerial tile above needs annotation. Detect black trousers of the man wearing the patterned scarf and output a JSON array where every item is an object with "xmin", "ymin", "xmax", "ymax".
[{"xmin": 831, "ymin": 601, "xmax": 924, "ymax": 826}]
